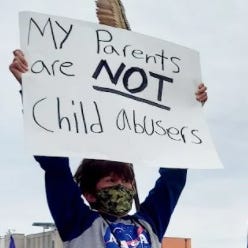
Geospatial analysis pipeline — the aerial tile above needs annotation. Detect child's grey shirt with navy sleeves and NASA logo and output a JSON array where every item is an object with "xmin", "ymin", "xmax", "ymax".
[{"xmin": 35, "ymin": 156, "xmax": 187, "ymax": 248}]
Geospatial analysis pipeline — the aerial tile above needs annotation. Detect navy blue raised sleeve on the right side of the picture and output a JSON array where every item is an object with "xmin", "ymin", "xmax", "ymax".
[{"xmin": 137, "ymin": 168, "xmax": 187, "ymax": 240}]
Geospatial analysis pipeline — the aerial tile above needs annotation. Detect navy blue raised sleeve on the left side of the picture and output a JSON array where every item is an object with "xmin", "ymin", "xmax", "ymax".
[{"xmin": 35, "ymin": 156, "xmax": 97, "ymax": 241}]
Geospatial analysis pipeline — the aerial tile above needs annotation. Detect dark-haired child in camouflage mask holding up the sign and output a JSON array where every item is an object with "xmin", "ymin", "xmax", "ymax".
[{"xmin": 10, "ymin": 50, "xmax": 207, "ymax": 248}]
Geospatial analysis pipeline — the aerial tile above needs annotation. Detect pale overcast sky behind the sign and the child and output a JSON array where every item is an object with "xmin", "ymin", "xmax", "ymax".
[{"xmin": 0, "ymin": 0, "xmax": 248, "ymax": 248}]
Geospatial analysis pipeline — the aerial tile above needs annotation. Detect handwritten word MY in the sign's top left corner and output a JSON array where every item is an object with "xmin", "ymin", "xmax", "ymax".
[{"xmin": 27, "ymin": 17, "xmax": 73, "ymax": 49}]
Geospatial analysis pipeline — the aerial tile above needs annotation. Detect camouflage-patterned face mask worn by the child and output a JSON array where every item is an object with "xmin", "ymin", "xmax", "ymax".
[{"xmin": 94, "ymin": 184, "xmax": 135, "ymax": 217}]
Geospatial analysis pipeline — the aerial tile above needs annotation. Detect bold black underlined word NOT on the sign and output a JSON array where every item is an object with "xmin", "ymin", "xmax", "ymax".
[{"xmin": 92, "ymin": 59, "xmax": 173, "ymax": 110}]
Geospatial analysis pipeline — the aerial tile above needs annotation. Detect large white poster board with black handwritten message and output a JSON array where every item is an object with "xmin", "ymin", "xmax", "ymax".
[{"xmin": 20, "ymin": 12, "xmax": 221, "ymax": 168}]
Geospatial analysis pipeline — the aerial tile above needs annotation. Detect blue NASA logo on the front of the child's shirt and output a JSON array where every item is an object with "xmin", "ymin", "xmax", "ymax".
[{"xmin": 104, "ymin": 223, "xmax": 151, "ymax": 248}]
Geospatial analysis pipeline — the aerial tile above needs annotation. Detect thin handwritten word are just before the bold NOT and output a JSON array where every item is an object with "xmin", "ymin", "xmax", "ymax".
[{"xmin": 31, "ymin": 59, "xmax": 75, "ymax": 77}]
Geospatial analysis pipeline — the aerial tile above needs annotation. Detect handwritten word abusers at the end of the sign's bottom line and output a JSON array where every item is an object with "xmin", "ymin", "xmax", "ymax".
[{"xmin": 116, "ymin": 109, "xmax": 203, "ymax": 144}]
